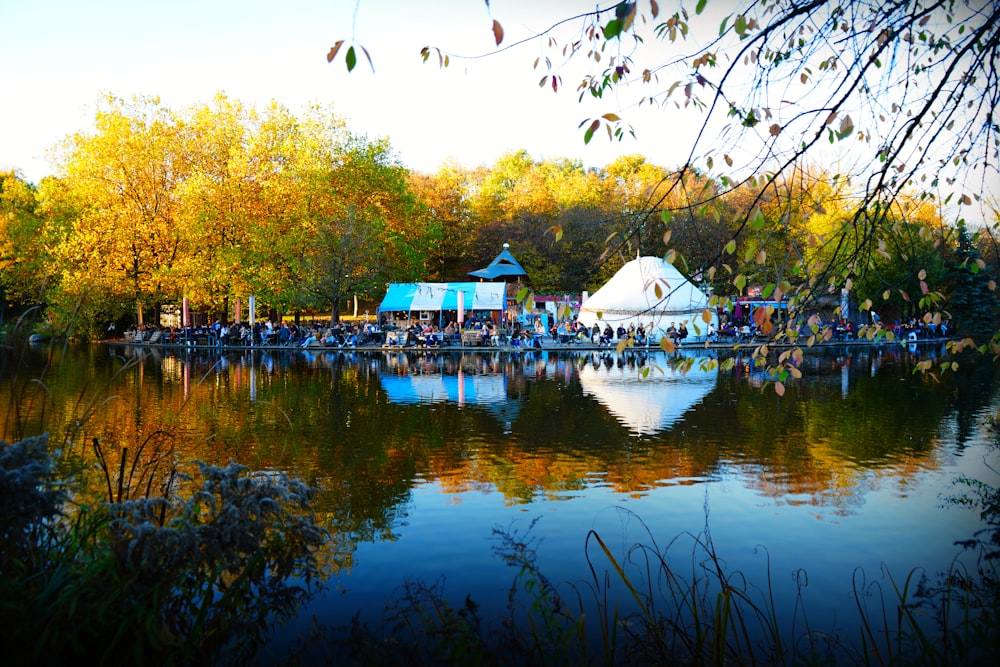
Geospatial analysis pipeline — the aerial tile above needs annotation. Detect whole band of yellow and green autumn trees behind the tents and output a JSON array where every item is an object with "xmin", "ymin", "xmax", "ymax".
[{"xmin": 0, "ymin": 94, "xmax": 997, "ymax": 337}]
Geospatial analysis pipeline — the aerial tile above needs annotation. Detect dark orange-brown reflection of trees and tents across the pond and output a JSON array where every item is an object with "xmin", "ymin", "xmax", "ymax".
[{"xmin": 0, "ymin": 345, "xmax": 994, "ymax": 565}]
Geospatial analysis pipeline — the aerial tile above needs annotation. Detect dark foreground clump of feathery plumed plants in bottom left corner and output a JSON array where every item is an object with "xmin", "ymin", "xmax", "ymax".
[{"xmin": 0, "ymin": 314, "xmax": 328, "ymax": 665}]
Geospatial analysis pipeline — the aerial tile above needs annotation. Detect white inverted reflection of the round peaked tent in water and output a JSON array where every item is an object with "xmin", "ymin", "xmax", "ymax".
[{"xmin": 580, "ymin": 362, "xmax": 719, "ymax": 435}]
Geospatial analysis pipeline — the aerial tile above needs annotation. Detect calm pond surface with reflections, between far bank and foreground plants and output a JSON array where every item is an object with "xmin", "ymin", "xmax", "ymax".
[{"xmin": 0, "ymin": 346, "xmax": 1000, "ymax": 650}]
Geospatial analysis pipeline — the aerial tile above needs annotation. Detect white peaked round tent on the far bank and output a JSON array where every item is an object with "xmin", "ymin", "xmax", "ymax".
[{"xmin": 578, "ymin": 257, "xmax": 719, "ymax": 340}]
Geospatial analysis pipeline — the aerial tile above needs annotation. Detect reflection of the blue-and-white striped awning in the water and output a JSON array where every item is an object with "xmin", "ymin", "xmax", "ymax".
[{"xmin": 381, "ymin": 373, "xmax": 520, "ymax": 424}]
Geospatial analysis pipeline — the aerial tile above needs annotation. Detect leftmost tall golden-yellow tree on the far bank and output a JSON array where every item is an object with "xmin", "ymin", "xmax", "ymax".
[{"xmin": 47, "ymin": 95, "xmax": 186, "ymax": 334}]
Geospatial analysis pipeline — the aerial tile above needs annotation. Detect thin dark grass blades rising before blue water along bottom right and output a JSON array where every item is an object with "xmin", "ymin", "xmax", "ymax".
[{"xmin": 324, "ymin": 507, "xmax": 1000, "ymax": 667}]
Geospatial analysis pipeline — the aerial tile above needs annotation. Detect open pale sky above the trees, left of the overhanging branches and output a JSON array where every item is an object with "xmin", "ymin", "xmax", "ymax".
[{"xmin": 0, "ymin": 0, "xmax": 694, "ymax": 181}]
